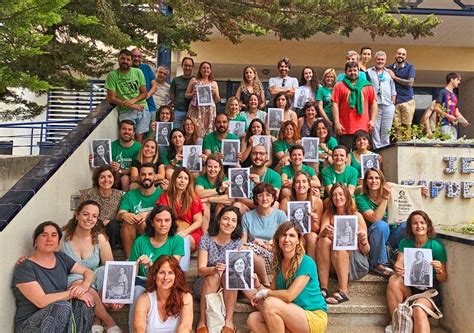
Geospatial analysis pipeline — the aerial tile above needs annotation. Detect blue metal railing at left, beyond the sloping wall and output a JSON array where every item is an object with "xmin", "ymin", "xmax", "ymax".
[{"xmin": 0, "ymin": 119, "xmax": 82, "ymax": 155}]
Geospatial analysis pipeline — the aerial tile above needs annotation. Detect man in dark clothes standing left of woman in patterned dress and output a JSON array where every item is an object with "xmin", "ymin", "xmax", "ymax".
[{"xmin": 170, "ymin": 57, "xmax": 194, "ymax": 128}]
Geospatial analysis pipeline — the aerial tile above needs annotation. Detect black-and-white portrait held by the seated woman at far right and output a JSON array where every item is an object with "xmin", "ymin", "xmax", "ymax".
[{"xmin": 403, "ymin": 248, "xmax": 433, "ymax": 288}]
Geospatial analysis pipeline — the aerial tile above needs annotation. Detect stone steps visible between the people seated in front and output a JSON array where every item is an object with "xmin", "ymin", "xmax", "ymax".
[{"xmin": 112, "ymin": 250, "xmax": 447, "ymax": 333}]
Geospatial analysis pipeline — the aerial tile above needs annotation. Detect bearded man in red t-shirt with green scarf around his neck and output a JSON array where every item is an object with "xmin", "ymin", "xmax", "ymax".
[{"xmin": 331, "ymin": 62, "xmax": 377, "ymax": 147}]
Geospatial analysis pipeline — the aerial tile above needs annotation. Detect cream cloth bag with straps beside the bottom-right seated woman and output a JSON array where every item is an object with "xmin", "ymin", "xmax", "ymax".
[{"xmin": 392, "ymin": 289, "xmax": 443, "ymax": 333}]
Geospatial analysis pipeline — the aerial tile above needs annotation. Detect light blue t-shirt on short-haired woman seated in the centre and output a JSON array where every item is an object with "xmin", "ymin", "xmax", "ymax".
[{"xmin": 242, "ymin": 208, "xmax": 287, "ymax": 242}]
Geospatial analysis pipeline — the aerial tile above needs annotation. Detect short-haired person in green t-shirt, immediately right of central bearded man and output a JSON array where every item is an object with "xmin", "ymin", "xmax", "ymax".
[{"xmin": 281, "ymin": 145, "xmax": 321, "ymax": 198}]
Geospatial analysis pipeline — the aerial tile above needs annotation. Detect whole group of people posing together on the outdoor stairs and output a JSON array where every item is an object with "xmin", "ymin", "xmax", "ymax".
[{"xmin": 12, "ymin": 48, "xmax": 460, "ymax": 333}]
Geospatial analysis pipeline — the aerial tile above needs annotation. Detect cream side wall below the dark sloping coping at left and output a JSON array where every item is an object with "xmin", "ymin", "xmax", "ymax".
[{"xmin": 0, "ymin": 110, "xmax": 118, "ymax": 332}]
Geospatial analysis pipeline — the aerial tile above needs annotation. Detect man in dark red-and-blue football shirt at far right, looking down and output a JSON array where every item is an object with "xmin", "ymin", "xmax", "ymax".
[{"xmin": 435, "ymin": 73, "xmax": 469, "ymax": 139}]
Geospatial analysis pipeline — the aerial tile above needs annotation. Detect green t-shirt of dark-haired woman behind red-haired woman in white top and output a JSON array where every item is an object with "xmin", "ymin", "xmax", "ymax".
[{"xmin": 128, "ymin": 235, "xmax": 184, "ymax": 276}]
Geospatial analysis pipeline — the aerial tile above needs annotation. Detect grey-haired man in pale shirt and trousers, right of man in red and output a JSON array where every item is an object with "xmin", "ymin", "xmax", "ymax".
[{"xmin": 367, "ymin": 51, "xmax": 397, "ymax": 148}]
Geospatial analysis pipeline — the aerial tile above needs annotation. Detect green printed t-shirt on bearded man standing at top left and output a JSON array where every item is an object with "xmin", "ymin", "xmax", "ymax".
[{"xmin": 105, "ymin": 67, "xmax": 147, "ymax": 111}]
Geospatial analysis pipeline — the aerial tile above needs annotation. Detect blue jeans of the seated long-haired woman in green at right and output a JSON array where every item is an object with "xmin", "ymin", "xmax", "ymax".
[{"xmin": 369, "ymin": 221, "xmax": 407, "ymax": 268}]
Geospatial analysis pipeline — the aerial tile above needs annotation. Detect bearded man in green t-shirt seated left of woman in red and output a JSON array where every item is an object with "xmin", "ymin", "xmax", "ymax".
[{"xmin": 117, "ymin": 163, "xmax": 163, "ymax": 258}]
